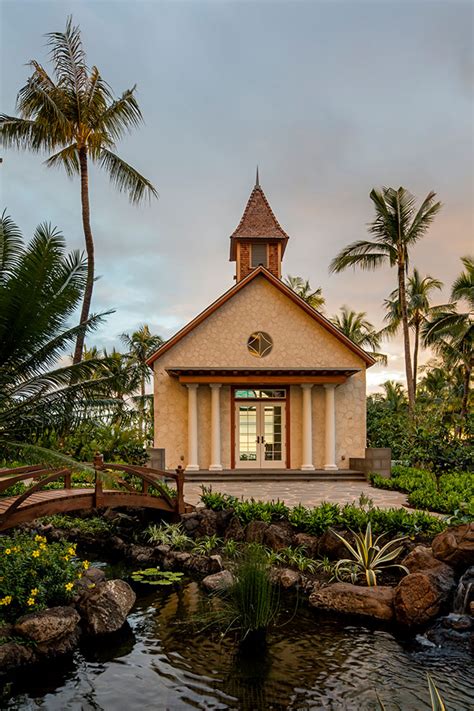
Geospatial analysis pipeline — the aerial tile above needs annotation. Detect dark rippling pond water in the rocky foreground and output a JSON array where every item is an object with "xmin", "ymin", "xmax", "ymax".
[{"xmin": 0, "ymin": 582, "xmax": 474, "ymax": 711}]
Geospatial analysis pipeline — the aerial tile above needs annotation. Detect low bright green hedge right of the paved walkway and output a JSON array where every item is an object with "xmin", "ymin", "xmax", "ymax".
[{"xmin": 370, "ymin": 466, "xmax": 474, "ymax": 518}]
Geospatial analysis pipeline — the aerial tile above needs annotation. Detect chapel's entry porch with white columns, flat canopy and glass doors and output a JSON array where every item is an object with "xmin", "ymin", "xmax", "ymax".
[{"xmin": 166, "ymin": 368, "xmax": 360, "ymax": 474}]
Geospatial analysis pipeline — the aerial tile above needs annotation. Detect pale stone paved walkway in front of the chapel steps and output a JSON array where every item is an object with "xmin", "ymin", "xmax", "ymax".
[{"xmin": 184, "ymin": 480, "xmax": 408, "ymax": 509}]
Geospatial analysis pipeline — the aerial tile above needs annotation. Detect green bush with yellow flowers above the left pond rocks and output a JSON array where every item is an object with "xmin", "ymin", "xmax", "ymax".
[{"xmin": 0, "ymin": 533, "xmax": 89, "ymax": 621}]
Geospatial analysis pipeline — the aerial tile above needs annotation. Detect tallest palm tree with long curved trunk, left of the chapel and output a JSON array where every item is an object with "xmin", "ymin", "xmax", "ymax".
[{"xmin": 0, "ymin": 17, "xmax": 157, "ymax": 363}]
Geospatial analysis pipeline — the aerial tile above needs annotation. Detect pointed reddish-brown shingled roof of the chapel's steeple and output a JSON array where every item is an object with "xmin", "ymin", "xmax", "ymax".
[{"xmin": 230, "ymin": 181, "xmax": 289, "ymax": 261}]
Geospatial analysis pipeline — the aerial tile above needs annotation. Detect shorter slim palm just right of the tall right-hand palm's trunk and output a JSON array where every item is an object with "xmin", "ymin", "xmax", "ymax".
[{"xmin": 382, "ymin": 267, "xmax": 443, "ymax": 397}]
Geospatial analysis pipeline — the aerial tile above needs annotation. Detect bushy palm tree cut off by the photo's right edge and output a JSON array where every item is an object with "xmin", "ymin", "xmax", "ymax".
[{"xmin": 422, "ymin": 257, "xmax": 474, "ymax": 422}]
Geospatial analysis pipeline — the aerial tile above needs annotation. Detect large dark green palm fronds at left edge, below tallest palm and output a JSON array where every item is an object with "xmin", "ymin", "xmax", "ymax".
[{"xmin": 0, "ymin": 213, "xmax": 110, "ymax": 441}]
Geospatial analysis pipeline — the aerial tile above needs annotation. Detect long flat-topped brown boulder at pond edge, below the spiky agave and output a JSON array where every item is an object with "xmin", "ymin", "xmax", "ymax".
[{"xmin": 309, "ymin": 583, "xmax": 393, "ymax": 620}]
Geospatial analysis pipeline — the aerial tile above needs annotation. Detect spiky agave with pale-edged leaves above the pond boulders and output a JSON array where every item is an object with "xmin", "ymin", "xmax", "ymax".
[{"xmin": 334, "ymin": 522, "xmax": 408, "ymax": 587}]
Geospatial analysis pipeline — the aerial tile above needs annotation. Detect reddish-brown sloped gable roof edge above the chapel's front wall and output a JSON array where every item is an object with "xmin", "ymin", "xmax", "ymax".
[{"xmin": 147, "ymin": 266, "xmax": 375, "ymax": 367}]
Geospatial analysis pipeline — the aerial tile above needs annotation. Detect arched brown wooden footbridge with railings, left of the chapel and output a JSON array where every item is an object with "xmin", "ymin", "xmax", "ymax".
[{"xmin": 0, "ymin": 455, "xmax": 193, "ymax": 531}]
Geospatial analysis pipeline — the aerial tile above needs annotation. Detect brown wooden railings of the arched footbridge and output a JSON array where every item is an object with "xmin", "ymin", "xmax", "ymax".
[{"xmin": 0, "ymin": 454, "xmax": 189, "ymax": 524}]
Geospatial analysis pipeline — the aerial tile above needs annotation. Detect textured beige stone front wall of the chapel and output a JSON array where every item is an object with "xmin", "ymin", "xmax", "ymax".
[{"xmin": 154, "ymin": 277, "xmax": 365, "ymax": 469}]
